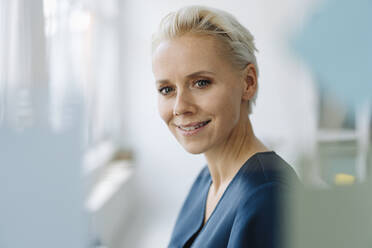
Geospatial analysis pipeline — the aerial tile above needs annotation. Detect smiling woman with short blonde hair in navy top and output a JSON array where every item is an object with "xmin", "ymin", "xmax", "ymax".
[{"xmin": 152, "ymin": 6, "xmax": 296, "ymax": 248}]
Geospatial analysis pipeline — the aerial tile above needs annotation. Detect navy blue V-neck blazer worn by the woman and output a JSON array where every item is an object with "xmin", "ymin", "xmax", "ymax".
[{"xmin": 168, "ymin": 151, "xmax": 299, "ymax": 248}]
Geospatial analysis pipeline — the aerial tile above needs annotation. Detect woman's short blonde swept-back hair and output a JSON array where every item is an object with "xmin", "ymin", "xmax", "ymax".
[{"xmin": 152, "ymin": 6, "xmax": 258, "ymax": 114}]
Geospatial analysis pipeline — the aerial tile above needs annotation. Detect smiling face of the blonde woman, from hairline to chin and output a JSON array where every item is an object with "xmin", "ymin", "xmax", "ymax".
[{"xmin": 152, "ymin": 34, "xmax": 247, "ymax": 154}]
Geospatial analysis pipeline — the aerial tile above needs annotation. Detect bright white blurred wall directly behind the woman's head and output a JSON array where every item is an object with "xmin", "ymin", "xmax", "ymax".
[{"xmin": 115, "ymin": 0, "xmax": 316, "ymax": 246}]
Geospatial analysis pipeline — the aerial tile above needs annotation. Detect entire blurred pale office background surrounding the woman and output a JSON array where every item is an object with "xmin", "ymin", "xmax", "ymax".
[{"xmin": 0, "ymin": 0, "xmax": 372, "ymax": 248}]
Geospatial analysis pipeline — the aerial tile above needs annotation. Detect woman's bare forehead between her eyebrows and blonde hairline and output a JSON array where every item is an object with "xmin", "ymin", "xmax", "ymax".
[{"xmin": 152, "ymin": 34, "xmax": 227, "ymax": 77}]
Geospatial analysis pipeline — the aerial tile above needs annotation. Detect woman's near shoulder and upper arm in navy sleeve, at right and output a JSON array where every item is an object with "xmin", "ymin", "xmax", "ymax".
[{"xmin": 225, "ymin": 152, "xmax": 301, "ymax": 247}]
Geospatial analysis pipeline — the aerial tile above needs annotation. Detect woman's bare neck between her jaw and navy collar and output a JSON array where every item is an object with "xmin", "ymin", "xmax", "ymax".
[{"xmin": 204, "ymin": 109, "xmax": 268, "ymax": 192}]
